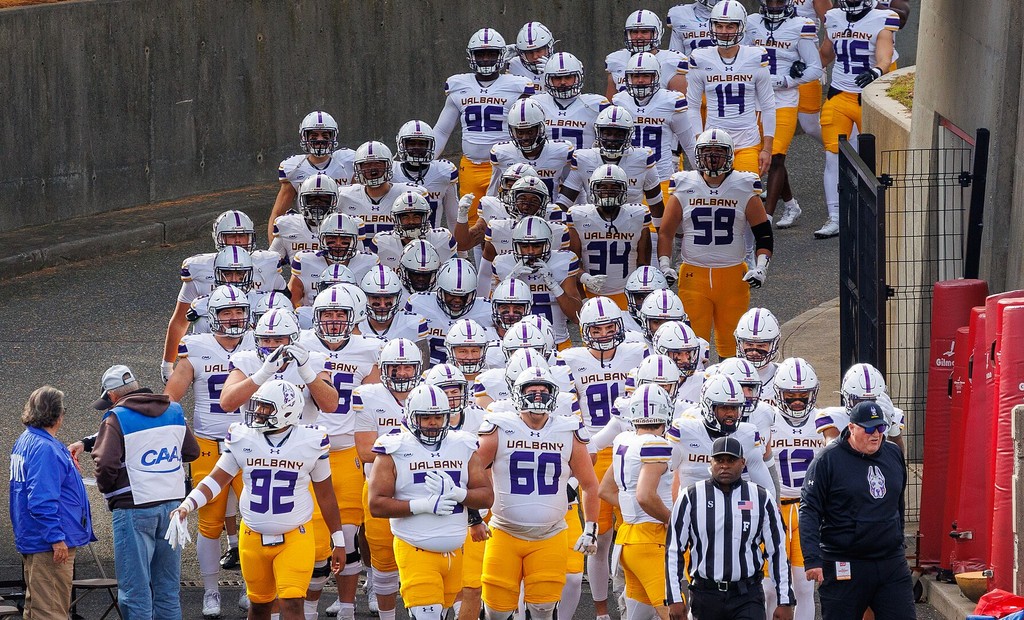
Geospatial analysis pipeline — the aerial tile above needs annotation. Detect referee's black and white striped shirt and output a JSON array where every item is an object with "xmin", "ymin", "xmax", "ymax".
[{"xmin": 666, "ymin": 480, "xmax": 794, "ymax": 605}]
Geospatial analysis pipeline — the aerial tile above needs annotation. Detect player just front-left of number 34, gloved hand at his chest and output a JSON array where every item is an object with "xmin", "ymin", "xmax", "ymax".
[{"xmin": 492, "ymin": 215, "xmax": 582, "ymax": 349}]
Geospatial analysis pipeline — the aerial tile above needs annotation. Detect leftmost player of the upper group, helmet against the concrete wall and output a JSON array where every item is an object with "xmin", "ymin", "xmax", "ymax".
[{"xmin": 267, "ymin": 111, "xmax": 355, "ymax": 244}]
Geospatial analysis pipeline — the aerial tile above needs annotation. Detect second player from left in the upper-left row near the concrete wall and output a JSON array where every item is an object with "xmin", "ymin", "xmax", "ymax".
[{"xmin": 338, "ymin": 140, "xmax": 427, "ymax": 254}]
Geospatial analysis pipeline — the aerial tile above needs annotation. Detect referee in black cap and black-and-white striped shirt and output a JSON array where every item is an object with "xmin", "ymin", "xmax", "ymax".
[{"xmin": 666, "ymin": 437, "xmax": 794, "ymax": 620}]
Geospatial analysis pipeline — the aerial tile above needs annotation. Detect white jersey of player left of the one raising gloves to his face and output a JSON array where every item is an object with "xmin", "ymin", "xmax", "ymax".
[{"xmin": 178, "ymin": 332, "xmax": 256, "ymax": 440}]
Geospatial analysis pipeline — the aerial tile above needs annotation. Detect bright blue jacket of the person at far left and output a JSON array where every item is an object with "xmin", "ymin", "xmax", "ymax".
[{"xmin": 10, "ymin": 426, "xmax": 96, "ymax": 553}]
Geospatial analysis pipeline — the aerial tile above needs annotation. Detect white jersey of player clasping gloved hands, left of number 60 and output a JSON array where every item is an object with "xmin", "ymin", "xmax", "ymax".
[{"xmin": 373, "ymin": 428, "xmax": 479, "ymax": 553}]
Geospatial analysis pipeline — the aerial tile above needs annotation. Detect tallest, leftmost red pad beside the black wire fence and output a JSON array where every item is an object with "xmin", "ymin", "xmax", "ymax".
[{"xmin": 918, "ymin": 280, "xmax": 988, "ymax": 567}]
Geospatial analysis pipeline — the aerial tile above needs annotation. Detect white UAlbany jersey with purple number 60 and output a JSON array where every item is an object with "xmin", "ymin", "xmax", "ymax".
[{"xmin": 480, "ymin": 413, "xmax": 589, "ymax": 540}]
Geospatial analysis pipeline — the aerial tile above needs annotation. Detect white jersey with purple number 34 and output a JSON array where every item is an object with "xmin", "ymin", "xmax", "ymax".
[{"xmin": 569, "ymin": 203, "xmax": 651, "ymax": 295}]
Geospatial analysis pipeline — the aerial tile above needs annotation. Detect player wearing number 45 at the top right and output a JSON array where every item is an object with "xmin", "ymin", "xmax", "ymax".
[{"xmin": 814, "ymin": 0, "xmax": 900, "ymax": 239}]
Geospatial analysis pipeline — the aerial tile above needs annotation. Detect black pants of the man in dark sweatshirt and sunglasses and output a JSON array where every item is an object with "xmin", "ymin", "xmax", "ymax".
[{"xmin": 818, "ymin": 556, "xmax": 918, "ymax": 620}]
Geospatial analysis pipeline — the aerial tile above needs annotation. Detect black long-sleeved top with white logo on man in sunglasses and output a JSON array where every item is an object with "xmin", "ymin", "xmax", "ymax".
[{"xmin": 800, "ymin": 429, "xmax": 906, "ymax": 569}]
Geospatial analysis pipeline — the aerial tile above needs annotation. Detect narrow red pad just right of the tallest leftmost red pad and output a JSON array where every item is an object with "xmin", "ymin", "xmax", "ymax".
[{"xmin": 937, "ymin": 327, "xmax": 971, "ymax": 571}]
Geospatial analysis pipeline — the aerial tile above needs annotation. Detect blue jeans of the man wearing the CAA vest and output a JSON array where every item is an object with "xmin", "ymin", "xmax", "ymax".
[{"xmin": 114, "ymin": 500, "xmax": 181, "ymax": 620}]
